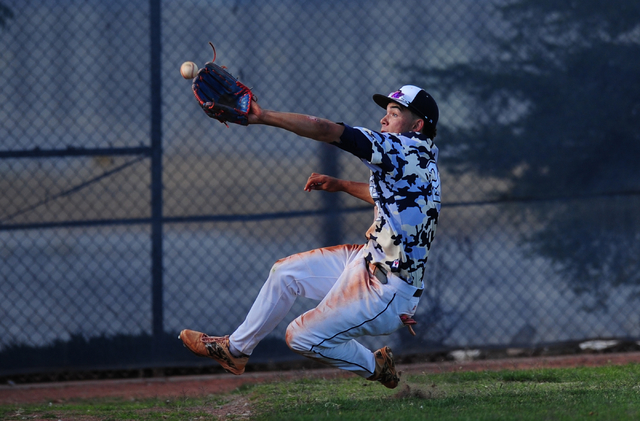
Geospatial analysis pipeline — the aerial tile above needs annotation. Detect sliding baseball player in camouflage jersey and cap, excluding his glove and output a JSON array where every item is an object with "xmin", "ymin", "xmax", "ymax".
[{"xmin": 179, "ymin": 85, "xmax": 440, "ymax": 388}]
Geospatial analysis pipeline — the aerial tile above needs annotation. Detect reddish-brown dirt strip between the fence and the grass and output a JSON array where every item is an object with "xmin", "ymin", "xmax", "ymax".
[{"xmin": 0, "ymin": 352, "xmax": 640, "ymax": 406}]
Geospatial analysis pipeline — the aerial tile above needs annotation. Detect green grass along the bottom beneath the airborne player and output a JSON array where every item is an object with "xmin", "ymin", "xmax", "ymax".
[{"xmin": 0, "ymin": 364, "xmax": 640, "ymax": 421}]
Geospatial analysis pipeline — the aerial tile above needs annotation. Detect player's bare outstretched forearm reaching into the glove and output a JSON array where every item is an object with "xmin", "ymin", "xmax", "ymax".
[{"xmin": 248, "ymin": 101, "xmax": 344, "ymax": 143}]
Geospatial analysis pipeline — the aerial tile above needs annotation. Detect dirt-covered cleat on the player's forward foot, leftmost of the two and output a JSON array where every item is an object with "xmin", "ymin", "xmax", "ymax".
[{"xmin": 178, "ymin": 329, "xmax": 249, "ymax": 375}]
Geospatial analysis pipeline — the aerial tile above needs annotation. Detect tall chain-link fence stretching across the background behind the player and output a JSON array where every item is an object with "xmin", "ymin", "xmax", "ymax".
[{"xmin": 0, "ymin": 0, "xmax": 640, "ymax": 375}]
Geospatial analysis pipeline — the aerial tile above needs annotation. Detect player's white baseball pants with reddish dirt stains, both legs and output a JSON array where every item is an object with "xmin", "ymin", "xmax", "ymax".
[{"xmin": 230, "ymin": 245, "xmax": 419, "ymax": 378}]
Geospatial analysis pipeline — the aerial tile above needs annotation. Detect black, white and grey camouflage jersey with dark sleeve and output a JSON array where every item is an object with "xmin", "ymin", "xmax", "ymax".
[{"xmin": 337, "ymin": 126, "xmax": 440, "ymax": 288}]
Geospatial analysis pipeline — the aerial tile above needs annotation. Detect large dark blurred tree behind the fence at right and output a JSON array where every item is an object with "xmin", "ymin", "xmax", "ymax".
[{"xmin": 413, "ymin": 0, "xmax": 640, "ymax": 306}]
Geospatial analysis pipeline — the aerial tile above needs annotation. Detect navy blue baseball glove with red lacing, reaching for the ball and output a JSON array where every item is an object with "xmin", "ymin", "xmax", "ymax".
[{"xmin": 191, "ymin": 43, "xmax": 253, "ymax": 127}]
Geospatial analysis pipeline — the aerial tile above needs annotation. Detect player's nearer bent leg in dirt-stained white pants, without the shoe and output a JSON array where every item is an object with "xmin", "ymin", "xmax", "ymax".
[{"xmin": 286, "ymin": 251, "xmax": 418, "ymax": 386}]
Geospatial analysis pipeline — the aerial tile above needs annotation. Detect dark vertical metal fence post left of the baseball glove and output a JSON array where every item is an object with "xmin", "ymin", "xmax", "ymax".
[{"xmin": 149, "ymin": 0, "xmax": 164, "ymax": 360}]
